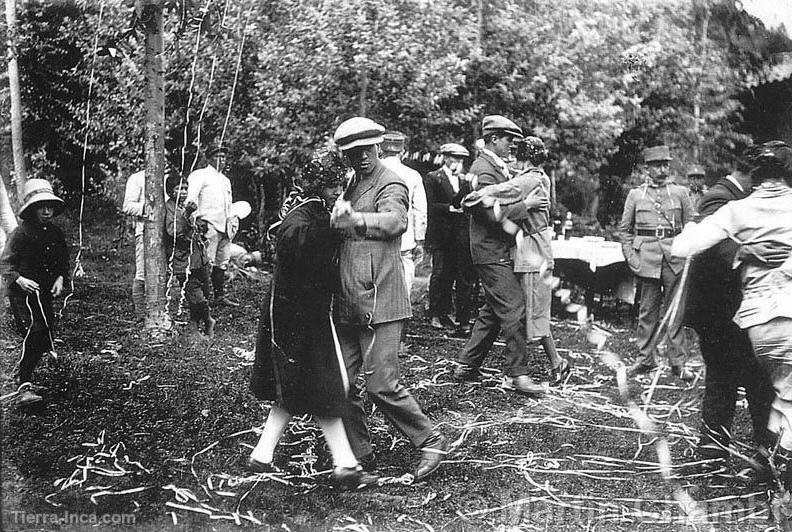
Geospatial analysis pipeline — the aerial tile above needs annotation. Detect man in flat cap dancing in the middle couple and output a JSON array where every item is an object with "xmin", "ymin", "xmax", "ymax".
[{"xmin": 454, "ymin": 115, "xmax": 544, "ymax": 395}]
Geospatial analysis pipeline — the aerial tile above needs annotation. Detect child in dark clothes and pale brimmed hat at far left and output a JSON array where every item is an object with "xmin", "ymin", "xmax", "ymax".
[{"xmin": 0, "ymin": 179, "xmax": 70, "ymax": 406}]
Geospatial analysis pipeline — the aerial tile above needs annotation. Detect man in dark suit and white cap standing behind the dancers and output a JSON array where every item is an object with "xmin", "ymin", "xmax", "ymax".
[{"xmin": 424, "ymin": 143, "xmax": 476, "ymax": 335}]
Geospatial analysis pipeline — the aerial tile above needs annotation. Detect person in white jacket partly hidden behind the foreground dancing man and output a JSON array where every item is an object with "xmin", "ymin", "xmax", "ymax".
[{"xmin": 380, "ymin": 131, "xmax": 426, "ymax": 294}]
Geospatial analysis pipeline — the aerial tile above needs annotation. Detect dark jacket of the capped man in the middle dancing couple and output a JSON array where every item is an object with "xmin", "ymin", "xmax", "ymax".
[{"xmin": 470, "ymin": 153, "xmax": 528, "ymax": 264}]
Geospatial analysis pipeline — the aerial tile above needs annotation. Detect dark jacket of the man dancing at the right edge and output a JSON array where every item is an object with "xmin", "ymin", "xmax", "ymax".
[{"xmin": 685, "ymin": 178, "xmax": 747, "ymax": 334}]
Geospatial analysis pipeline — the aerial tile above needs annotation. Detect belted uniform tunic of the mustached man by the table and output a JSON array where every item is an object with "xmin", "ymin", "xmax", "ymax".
[{"xmin": 619, "ymin": 183, "xmax": 694, "ymax": 279}]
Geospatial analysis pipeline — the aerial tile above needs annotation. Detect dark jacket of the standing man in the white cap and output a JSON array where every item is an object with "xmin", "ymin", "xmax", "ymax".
[{"xmin": 424, "ymin": 168, "xmax": 470, "ymax": 249}]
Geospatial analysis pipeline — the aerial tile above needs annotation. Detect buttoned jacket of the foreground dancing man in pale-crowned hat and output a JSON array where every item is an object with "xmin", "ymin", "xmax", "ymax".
[{"xmin": 335, "ymin": 161, "xmax": 412, "ymax": 325}]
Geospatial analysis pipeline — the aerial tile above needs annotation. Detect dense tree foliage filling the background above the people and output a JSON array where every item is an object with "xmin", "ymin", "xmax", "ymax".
[{"xmin": 7, "ymin": 0, "xmax": 792, "ymax": 241}]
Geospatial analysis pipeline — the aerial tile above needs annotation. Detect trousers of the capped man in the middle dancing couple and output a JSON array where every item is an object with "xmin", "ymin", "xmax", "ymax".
[{"xmin": 457, "ymin": 262, "xmax": 528, "ymax": 377}]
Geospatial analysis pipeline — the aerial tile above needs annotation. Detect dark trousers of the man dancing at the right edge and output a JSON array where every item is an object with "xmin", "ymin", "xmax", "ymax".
[{"xmin": 698, "ymin": 322, "xmax": 775, "ymax": 454}]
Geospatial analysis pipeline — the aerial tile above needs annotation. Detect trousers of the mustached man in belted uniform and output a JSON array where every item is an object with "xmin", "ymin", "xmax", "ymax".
[{"xmin": 636, "ymin": 259, "xmax": 687, "ymax": 366}]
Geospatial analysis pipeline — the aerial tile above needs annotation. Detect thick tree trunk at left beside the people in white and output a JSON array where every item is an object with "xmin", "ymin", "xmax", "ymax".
[{"xmin": 138, "ymin": 0, "xmax": 170, "ymax": 337}]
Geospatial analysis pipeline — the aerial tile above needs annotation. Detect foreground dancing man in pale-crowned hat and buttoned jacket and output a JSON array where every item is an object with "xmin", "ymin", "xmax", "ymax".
[{"xmin": 331, "ymin": 117, "xmax": 448, "ymax": 480}]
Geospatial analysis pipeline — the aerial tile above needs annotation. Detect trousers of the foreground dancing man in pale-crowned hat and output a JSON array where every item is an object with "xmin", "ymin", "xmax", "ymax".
[{"xmin": 336, "ymin": 320, "xmax": 433, "ymax": 458}]
